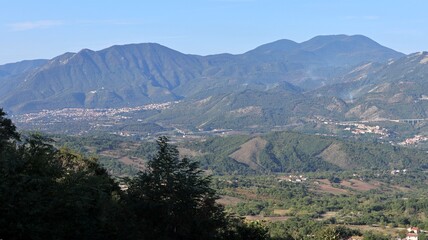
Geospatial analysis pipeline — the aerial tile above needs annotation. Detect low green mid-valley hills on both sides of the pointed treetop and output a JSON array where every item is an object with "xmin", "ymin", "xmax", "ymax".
[{"xmin": 58, "ymin": 132, "xmax": 428, "ymax": 175}]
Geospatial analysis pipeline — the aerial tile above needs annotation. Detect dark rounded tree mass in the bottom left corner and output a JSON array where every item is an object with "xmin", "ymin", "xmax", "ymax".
[{"xmin": 0, "ymin": 123, "xmax": 126, "ymax": 239}]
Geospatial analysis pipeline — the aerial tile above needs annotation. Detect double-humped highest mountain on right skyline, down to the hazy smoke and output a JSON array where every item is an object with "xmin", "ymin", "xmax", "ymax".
[{"xmin": 239, "ymin": 35, "xmax": 404, "ymax": 89}]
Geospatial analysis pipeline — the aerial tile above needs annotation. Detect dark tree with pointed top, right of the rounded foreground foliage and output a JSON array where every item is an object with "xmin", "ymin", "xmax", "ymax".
[{"xmin": 127, "ymin": 137, "xmax": 226, "ymax": 239}]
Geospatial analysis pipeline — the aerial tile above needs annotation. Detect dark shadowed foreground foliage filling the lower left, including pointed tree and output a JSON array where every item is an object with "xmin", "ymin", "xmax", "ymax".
[{"xmin": 0, "ymin": 109, "xmax": 268, "ymax": 240}]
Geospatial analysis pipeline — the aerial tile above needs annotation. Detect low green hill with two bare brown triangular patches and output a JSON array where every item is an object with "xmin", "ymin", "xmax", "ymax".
[{"xmin": 186, "ymin": 132, "xmax": 428, "ymax": 174}]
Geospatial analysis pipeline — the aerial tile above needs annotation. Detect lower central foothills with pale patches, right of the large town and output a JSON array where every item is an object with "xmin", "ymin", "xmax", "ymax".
[{"xmin": 148, "ymin": 85, "xmax": 348, "ymax": 130}]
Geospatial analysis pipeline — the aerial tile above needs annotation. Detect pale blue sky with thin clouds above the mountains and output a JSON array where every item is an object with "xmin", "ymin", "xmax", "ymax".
[{"xmin": 0, "ymin": 0, "xmax": 428, "ymax": 64}]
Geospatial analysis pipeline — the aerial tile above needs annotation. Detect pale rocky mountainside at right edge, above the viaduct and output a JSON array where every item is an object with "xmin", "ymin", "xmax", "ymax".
[{"xmin": 313, "ymin": 52, "xmax": 428, "ymax": 120}]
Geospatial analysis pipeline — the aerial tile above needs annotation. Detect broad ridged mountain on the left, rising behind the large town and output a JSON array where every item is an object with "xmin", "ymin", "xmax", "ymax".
[{"xmin": 4, "ymin": 44, "xmax": 206, "ymax": 111}]
